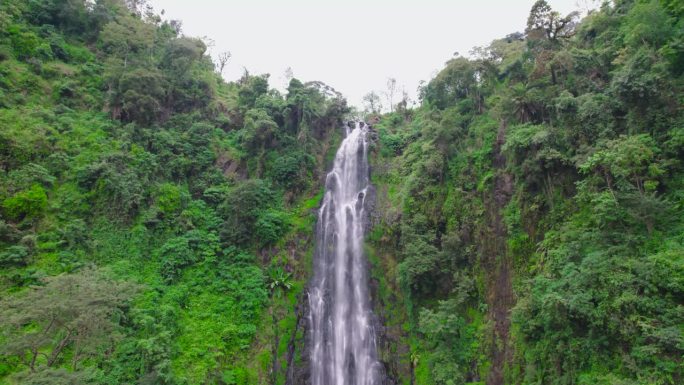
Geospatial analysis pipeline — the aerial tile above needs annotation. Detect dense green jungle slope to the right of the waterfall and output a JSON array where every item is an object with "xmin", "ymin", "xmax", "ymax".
[{"xmin": 369, "ymin": 0, "xmax": 684, "ymax": 385}]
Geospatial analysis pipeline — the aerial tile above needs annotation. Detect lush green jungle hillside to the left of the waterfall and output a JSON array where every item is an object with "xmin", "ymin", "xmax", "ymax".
[{"xmin": 0, "ymin": 0, "xmax": 348, "ymax": 384}]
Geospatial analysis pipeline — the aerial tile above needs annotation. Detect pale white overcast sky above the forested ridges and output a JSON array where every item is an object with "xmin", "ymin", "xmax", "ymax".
[{"xmin": 150, "ymin": 0, "xmax": 591, "ymax": 106}]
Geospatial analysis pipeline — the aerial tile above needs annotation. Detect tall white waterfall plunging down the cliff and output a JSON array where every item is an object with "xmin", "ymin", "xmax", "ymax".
[{"xmin": 309, "ymin": 122, "xmax": 382, "ymax": 385}]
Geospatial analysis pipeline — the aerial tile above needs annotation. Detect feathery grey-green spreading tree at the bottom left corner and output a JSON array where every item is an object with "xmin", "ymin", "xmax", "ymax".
[{"xmin": 0, "ymin": 268, "xmax": 139, "ymax": 371}]
